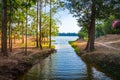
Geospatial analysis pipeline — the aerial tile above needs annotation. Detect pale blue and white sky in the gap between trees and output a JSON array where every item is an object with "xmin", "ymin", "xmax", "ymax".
[{"xmin": 57, "ymin": 9, "xmax": 80, "ymax": 33}]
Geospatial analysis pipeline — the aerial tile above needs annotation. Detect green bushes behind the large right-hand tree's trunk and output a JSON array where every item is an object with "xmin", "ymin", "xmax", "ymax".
[{"xmin": 78, "ymin": 16, "xmax": 120, "ymax": 40}]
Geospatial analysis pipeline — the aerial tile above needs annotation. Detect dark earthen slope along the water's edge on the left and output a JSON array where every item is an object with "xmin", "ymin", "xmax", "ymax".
[{"xmin": 0, "ymin": 49, "xmax": 55, "ymax": 80}]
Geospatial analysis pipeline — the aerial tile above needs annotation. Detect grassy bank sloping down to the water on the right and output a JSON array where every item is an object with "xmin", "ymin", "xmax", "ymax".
[{"xmin": 69, "ymin": 41, "xmax": 120, "ymax": 80}]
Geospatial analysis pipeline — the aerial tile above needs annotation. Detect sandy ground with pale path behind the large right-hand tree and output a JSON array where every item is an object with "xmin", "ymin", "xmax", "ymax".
[{"xmin": 75, "ymin": 34, "xmax": 120, "ymax": 54}]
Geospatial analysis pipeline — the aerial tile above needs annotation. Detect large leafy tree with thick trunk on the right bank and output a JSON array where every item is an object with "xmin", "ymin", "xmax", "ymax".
[{"xmin": 66, "ymin": 0, "xmax": 115, "ymax": 51}]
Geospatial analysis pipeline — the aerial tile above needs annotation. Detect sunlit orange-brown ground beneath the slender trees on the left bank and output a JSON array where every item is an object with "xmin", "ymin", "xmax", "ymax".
[{"xmin": 0, "ymin": 36, "xmax": 55, "ymax": 70}]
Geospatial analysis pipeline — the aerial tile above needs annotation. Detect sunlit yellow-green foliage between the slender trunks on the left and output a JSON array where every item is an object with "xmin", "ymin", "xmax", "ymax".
[{"xmin": 0, "ymin": 0, "xmax": 60, "ymax": 36}]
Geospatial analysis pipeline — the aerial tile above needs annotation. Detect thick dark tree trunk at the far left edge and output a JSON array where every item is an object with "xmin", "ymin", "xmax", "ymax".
[{"xmin": 1, "ymin": 0, "xmax": 8, "ymax": 56}]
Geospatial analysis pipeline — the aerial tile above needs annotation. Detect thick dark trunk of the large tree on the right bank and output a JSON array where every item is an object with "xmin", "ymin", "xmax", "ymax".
[{"xmin": 85, "ymin": 1, "xmax": 96, "ymax": 51}]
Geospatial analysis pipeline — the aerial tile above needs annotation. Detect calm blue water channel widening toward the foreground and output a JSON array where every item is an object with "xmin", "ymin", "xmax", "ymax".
[{"xmin": 19, "ymin": 37, "xmax": 111, "ymax": 80}]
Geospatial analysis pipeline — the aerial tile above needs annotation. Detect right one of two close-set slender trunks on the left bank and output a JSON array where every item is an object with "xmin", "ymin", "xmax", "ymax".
[{"xmin": 39, "ymin": 0, "xmax": 42, "ymax": 49}]
